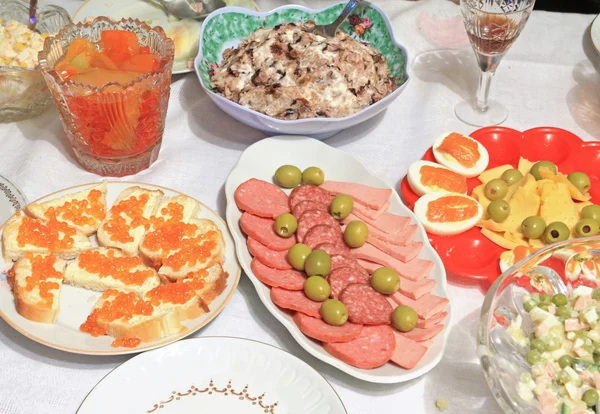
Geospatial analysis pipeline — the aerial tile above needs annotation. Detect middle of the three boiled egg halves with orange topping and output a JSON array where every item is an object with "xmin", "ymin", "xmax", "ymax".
[{"xmin": 407, "ymin": 160, "xmax": 468, "ymax": 196}]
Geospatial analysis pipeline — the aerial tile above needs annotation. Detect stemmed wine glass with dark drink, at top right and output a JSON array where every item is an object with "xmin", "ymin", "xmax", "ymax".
[{"xmin": 454, "ymin": 0, "xmax": 535, "ymax": 126}]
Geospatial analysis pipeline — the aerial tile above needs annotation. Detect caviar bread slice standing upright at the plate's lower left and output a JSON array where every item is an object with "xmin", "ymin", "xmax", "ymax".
[{"xmin": 12, "ymin": 254, "xmax": 67, "ymax": 323}]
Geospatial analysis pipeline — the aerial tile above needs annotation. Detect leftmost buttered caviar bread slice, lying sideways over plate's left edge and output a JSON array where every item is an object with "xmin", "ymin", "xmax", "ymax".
[{"xmin": 2, "ymin": 211, "xmax": 91, "ymax": 262}]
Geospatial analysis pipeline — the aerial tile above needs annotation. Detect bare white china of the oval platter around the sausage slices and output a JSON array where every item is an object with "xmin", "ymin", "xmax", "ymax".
[{"xmin": 225, "ymin": 135, "xmax": 452, "ymax": 384}]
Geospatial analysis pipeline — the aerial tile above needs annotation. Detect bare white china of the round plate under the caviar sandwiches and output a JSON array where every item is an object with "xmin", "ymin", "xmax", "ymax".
[{"xmin": 0, "ymin": 181, "xmax": 241, "ymax": 355}]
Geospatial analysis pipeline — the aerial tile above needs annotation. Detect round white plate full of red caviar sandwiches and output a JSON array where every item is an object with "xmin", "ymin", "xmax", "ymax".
[{"xmin": 0, "ymin": 181, "xmax": 240, "ymax": 355}]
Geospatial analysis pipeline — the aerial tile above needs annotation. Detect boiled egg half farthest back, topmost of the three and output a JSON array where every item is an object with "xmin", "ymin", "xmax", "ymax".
[{"xmin": 433, "ymin": 132, "xmax": 490, "ymax": 178}]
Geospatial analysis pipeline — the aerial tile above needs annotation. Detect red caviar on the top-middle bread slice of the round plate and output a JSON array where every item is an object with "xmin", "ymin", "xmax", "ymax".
[{"xmin": 105, "ymin": 194, "xmax": 150, "ymax": 243}]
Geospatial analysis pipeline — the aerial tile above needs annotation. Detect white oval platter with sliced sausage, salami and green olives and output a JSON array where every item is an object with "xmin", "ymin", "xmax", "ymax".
[{"xmin": 225, "ymin": 136, "xmax": 452, "ymax": 383}]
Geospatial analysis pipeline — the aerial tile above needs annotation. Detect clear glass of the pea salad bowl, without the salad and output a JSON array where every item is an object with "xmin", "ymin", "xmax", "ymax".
[{"xmin": 477, "ymin": 236, "xmax": 600, "ymax": 414}]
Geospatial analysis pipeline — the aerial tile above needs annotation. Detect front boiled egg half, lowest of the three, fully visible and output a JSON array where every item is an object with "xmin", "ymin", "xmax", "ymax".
[{"xmin": 414, "ymin": 192, "xmax": 483, "ymax": 236}]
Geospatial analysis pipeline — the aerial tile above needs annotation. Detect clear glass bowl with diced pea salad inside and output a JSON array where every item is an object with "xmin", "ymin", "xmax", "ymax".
[{"xmin": 477, "ymin": 236, "xmax": 600, "ymax": 414}]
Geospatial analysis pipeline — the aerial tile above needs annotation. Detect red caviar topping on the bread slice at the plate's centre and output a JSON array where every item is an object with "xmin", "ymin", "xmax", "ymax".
[{"xmin": 78, "ymin": 250, "xmax": 154, "ymax": 285}]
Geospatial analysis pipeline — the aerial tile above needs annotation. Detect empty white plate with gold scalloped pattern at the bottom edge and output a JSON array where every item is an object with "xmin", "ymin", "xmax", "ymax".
[{"xmin": 77, "ymin": 337, "xmax": 346, "ymax": 414}]
